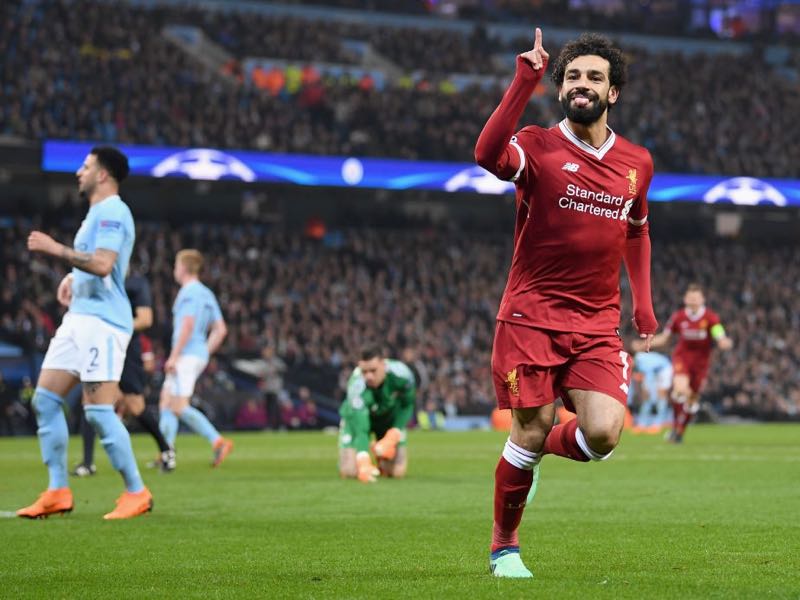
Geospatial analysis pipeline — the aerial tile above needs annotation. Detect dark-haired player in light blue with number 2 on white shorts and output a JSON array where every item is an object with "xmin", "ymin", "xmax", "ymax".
[{"xmin": 17, "ymin": 146, "xmax": 153, "ymax": 519}]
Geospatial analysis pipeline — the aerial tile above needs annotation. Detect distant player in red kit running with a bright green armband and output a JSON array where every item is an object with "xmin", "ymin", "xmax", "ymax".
[{"xmin": 652, "ymin": 283, "xmax": 733, "ymax": 443}]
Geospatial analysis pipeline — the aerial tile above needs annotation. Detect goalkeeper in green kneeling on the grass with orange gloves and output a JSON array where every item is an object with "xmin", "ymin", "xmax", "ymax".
[{"xmin": 339, "ymin": 347, "xmax": 416, "ymax": 483}]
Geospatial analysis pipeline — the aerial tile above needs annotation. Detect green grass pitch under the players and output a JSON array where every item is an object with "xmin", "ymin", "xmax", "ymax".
[{"xmin": 0, "ymin": 425, "xmax": 800, "ymax": 600}]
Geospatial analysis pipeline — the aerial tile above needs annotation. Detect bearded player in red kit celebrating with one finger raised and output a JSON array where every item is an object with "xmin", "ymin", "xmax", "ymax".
[{"xmin": 475, "ymin": 28, "xmax": 657, "ymax": 577}]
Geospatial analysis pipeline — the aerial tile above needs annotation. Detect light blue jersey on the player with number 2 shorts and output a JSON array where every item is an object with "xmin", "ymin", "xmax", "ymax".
[{"xmin": 69, "ymin": 195, "xmax": 136, "ymax": 334}]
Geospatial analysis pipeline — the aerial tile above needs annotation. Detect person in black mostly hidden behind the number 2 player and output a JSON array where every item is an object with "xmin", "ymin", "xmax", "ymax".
[{"xmin": 62, "ymin": 274, "xmax": 175, "ymax": 477}]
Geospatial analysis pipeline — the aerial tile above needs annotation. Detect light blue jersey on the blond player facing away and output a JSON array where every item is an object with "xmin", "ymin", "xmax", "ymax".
[{"xmin": 172, "ymin": 281, "xmax": 222, "ymax": 360}]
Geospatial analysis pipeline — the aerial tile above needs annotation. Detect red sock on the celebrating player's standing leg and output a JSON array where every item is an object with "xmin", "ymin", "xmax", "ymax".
[{"xmin": 492, "ymin": 456, "xmax": 533, "ymax": 552}]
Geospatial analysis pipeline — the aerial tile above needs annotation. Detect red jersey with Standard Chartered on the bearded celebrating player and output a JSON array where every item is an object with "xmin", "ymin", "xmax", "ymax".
[{"xmin": 497, "ymin": 121, "xmax": 653, "ymax": 335}]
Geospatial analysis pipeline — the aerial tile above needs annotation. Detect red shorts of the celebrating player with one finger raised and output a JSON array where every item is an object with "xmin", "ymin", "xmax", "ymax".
[{"xmin": 492, "ymin": 321, "xmax": 631, "ymax": 412}]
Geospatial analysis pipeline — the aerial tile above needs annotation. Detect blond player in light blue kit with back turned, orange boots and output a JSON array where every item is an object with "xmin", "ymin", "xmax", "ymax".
[{"xmin": 159, "ymin": 250, "xmax": 233, "ymax": 467}]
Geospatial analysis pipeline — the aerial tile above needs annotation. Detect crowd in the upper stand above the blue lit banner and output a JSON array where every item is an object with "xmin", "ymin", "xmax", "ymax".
[{"xmin": 0, "ymin": 0, "xmax": 800, "ymax": 177}]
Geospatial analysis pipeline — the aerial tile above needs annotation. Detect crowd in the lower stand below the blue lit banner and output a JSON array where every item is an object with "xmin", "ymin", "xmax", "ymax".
[{"xmin": 0, "ymin": 212, "xmax": 800, "ymax": 418}]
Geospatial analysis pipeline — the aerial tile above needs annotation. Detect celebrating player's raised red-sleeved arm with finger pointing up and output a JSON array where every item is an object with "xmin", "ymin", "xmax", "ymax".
[{"xmin": 475, "ymin": 27, "xmax": 550, "ymax": 181}]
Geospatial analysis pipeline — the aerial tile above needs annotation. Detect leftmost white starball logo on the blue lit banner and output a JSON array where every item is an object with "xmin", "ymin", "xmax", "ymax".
[{"xmin": 151, "ymin": 148, "xmax": 256, "ymax": 181}]
